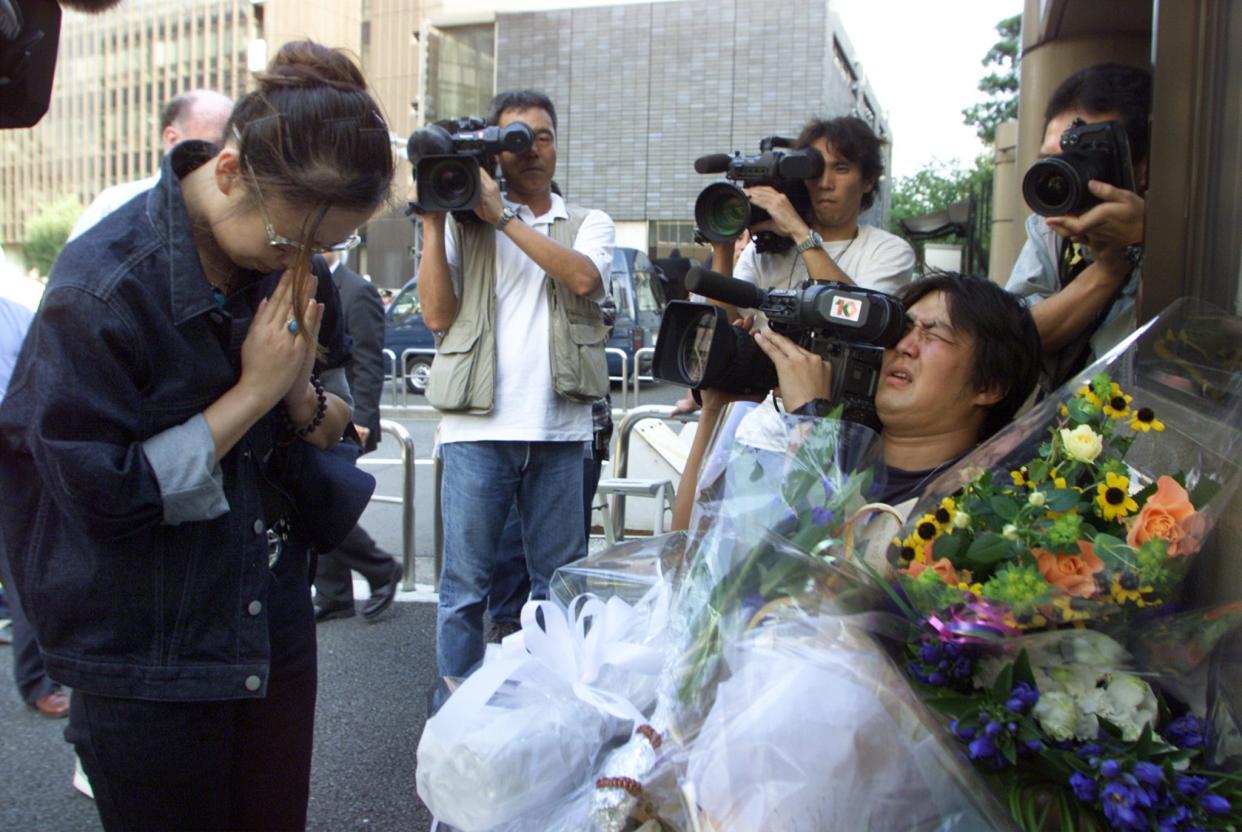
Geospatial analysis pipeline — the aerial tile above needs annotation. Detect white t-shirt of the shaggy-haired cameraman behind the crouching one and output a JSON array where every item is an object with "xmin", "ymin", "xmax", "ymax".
[{"xmin": 733, "ymin": 225, "xmax": 914, "ymax": 294}]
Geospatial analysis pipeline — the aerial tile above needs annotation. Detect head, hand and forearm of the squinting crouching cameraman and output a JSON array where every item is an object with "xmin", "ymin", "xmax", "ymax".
[{"xmin": 673, "ymin": 274, "xmax": 1040, "ymax": 529}]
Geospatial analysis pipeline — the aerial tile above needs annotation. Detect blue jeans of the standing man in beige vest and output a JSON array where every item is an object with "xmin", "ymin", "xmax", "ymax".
[{"xmin": 436, "ymin": 442, "xmax": 586, "ymax": 677}]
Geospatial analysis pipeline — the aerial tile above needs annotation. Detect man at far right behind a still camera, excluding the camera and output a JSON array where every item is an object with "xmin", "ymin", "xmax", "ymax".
[{"xmin": 1006, "ymin": 63, "xmax": 1151, "ymax": 391}]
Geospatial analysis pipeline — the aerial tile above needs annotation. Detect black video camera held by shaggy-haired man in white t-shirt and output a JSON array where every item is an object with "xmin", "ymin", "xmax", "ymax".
[{"xmin": 694, "ymin": 135, "xmax": 823, "ymax": 252}]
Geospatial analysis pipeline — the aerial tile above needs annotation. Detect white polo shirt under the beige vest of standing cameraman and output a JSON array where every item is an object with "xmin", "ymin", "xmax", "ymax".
[{"xmin": 440, "ymin": 194, "xmax": 616, "ymax": 443}]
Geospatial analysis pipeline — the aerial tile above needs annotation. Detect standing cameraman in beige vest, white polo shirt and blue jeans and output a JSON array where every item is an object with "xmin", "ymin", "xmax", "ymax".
[{"xmin": 419, "ymin": 91, "xmax": 616, "ymax": 699}]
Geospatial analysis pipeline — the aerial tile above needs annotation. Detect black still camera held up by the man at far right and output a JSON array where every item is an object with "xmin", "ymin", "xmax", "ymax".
[{"xmin": 1022, "ymin": 118, "xmax": 1134, "ymax": 216}]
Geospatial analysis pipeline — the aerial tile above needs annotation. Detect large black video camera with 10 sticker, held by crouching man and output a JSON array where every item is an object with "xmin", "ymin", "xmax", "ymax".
[{"xmin": 651, "ymin": 267, "xmax": 905, "ymax": 432}]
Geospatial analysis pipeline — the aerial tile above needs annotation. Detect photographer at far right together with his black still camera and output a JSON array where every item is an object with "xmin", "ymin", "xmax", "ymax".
[{"xmin": 1006, "ymin": 63, "xmax": 1151, "ymax": 391}]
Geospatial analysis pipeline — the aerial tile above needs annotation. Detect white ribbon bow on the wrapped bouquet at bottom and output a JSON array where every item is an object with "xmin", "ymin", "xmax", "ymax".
[{"xmin": 436, "ymin": 595, "xmax": 664, "ymax": 725}]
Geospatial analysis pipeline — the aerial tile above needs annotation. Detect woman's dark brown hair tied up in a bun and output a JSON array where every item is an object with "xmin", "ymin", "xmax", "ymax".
[{"xmin": 225, "ymin": 41, "xmax": 395, "ymax": 329}]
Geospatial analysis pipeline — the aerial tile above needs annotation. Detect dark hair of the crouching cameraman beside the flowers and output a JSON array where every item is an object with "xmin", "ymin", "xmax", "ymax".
[{"xmin": 897, "ymin": 272, "xmax": 1043, "ymax": 442}]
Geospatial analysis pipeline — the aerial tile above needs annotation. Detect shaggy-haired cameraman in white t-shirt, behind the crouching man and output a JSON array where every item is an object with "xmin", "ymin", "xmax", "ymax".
[{"xmin": 712, "ymin": 115, "xmax": 914, "ymax": 300}]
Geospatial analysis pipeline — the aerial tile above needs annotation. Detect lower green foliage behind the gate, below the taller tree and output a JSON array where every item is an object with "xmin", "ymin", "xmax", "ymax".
[{"xmin": 888, "ymin": 154, "xmax": 992, "ymax": 269}]
